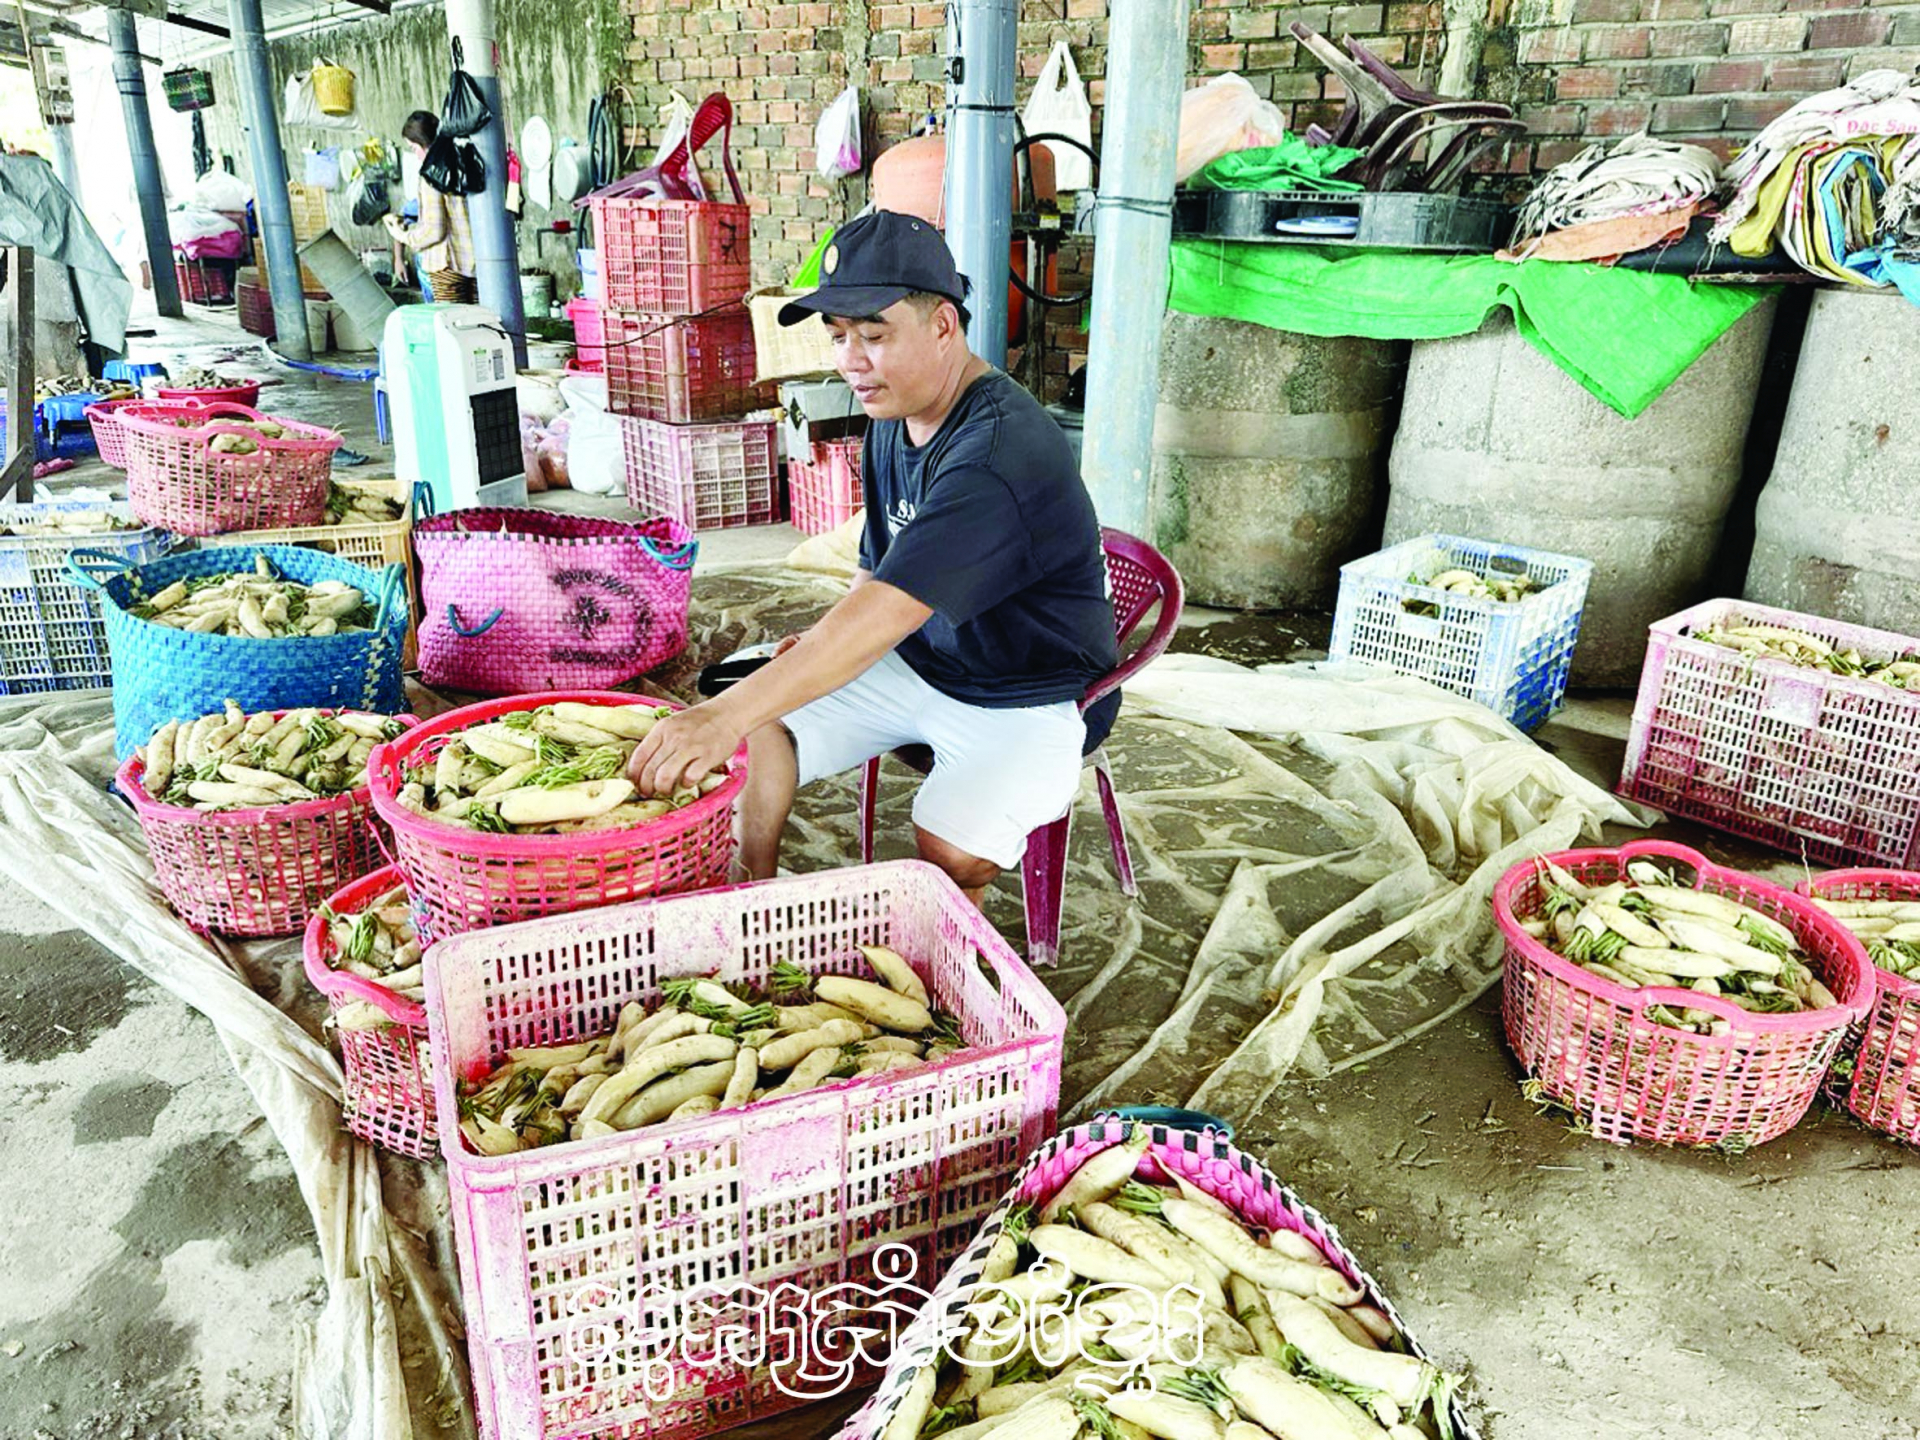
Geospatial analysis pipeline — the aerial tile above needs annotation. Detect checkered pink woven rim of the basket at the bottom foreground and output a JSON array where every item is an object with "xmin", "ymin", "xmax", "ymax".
[{"xmin": 837, "ymin": 1119, "xmax": 1480, "ymax": 1440}]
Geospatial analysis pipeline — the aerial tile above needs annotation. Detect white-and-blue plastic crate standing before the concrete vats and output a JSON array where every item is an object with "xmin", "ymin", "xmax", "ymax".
[{"xmin": 1329, "ymin": 536, "xmax": 1594, "ymax": 730}]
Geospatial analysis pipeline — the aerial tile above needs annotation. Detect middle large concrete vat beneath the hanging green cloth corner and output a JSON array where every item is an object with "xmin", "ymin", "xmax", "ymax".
[{"xmin": 1386, "ymin": 300, "xmax": 1776, "ymax": 685}]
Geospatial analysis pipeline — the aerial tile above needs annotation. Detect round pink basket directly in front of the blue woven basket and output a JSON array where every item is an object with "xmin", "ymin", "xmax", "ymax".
[{"xmin": 115, "ymin": 710, "xmax": 419, "ymax": 935}]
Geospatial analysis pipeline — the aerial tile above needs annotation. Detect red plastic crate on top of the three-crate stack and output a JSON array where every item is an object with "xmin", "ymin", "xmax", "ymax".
[{"xmin": 593, "ymin": 200, "xmax": 753, "ymax": 315}]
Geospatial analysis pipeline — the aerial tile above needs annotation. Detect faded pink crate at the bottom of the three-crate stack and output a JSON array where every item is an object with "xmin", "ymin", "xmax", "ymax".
[{"xmin": 620, "ymin": 419, "xmax": 780, "ymax": 530}]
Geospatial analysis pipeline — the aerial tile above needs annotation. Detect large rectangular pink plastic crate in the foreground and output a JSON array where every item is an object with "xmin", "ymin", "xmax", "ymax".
[{"xmin": 426, "ymin": 860, "xmax": 1066, "ymax": 1440}]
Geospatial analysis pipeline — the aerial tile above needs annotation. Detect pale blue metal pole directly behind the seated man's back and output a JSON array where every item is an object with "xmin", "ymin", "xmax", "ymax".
[{"xmin": 1081, "ymin": 0, "xmax": 1187, "ymax": 540}]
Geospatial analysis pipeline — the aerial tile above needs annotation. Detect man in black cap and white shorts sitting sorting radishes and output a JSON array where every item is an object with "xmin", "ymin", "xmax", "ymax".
[{"xmin": 630, "ymin": 211, "xmax": 1117, "ymax": 900}]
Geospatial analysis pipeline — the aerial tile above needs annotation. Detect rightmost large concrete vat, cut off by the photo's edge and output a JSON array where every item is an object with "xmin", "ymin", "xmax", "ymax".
[{"xmin": 1745, "ymin": 290, "xmax": 1920, "ymax": 636}]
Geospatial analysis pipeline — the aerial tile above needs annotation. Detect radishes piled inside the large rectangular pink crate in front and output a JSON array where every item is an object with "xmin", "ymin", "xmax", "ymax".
[{"xmin": 449, "ymin": 945, "xmax": 962, "ymax": 1156}]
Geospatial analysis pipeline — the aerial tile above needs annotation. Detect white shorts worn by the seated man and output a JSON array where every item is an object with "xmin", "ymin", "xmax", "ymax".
[{"xmin": 783, "ymin": 651, "xmax": 1087, "ymax": 870}]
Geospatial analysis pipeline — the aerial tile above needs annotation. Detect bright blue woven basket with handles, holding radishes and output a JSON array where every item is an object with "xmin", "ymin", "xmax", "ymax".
[{"xmin": 67, "ymin": 545, "xmax": 407, "ymax": 760}]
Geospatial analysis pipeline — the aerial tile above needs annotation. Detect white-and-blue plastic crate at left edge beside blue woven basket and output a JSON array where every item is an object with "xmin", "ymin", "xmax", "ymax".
[{"xmin": 0, "ymin": 499, "xmax": 171, "ymax": 695}]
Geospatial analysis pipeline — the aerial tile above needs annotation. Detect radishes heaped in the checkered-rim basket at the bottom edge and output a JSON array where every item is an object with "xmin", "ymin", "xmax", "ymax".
[{"xmin": 881, "ymin": 1127, "xmax": 1459, "ymax": 1440}]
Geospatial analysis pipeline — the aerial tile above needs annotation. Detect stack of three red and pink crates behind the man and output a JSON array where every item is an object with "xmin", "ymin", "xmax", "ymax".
[{"xmin": 599, "ymin": 198, "xmax": 780, "ymax": 530}]
